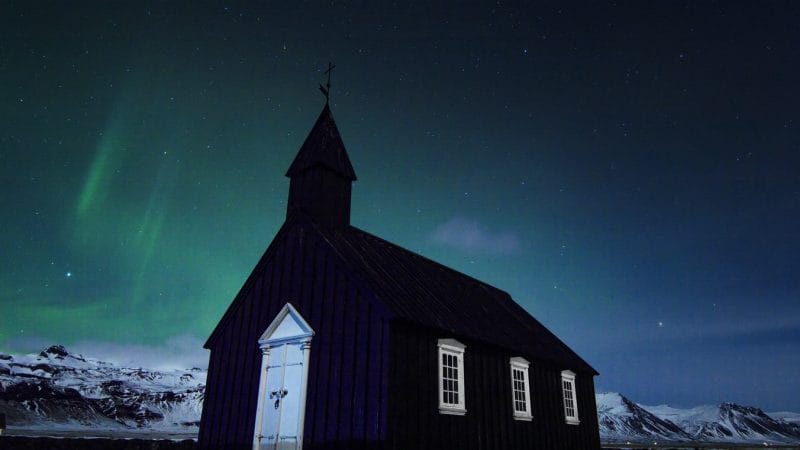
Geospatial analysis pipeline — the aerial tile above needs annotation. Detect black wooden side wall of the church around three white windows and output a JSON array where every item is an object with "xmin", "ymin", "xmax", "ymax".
[{"xmin": 387, "ymin": 322, "xmax": 600, "ymax": 450}]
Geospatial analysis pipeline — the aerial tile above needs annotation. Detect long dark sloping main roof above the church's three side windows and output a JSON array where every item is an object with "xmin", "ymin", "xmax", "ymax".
[{"xmin": 316, "ymin": 221, "xmax": 597, "ymax": 374}]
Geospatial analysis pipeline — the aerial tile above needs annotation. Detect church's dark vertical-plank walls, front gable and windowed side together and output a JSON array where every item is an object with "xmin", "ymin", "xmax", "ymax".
[{"xmin": 198, "ymin": 223, "xmax": 600, "ymax": 450}]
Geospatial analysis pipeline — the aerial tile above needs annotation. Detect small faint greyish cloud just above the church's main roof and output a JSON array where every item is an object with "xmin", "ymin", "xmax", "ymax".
[{"xmin": 431, "ymin": 217, "xmax": 520, "ymax": 255}]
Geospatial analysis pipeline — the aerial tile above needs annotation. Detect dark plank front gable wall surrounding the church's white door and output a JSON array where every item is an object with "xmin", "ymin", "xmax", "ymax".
[{"xmin": 198, "ymin": 222, "xmax": 388, "ymax": 450}]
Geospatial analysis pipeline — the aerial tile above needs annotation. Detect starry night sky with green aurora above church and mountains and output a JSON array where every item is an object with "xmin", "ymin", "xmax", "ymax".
[{"xmin": 0, "ymin": 0, "xmax": 800, "ymax": 410}]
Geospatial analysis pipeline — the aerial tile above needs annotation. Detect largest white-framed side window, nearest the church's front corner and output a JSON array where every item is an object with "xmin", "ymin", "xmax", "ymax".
[{"xmin": 439, "ymin": 339, "xmax": 467, "ymax": 416}]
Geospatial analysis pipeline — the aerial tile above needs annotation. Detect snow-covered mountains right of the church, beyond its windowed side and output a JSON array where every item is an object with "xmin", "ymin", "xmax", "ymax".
[{"xmin": 596, "ymin": 393, "xmax": 800, "ymax": 444}]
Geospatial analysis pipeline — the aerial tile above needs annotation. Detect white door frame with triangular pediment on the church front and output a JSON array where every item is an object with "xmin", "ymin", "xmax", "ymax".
[{"xmin": 253, "ymin": 302, "xmax": 314, "ymax": 450}]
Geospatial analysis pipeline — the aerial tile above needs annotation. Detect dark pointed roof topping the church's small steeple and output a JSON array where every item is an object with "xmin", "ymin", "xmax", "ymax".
[{"xmin": 286, "ymin": 104, "xmax": 356, "ymax": 181}]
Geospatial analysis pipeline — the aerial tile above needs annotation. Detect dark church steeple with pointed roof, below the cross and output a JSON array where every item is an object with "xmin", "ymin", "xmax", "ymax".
[{"xmin": 286, "ymin": 103, "xmax": 356, "ymax": 227}]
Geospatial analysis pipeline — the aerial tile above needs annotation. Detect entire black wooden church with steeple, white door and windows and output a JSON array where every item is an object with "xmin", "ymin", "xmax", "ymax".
[{"xmin": 198, "ymin": 99, "xmax": 600, "ymax": 450}]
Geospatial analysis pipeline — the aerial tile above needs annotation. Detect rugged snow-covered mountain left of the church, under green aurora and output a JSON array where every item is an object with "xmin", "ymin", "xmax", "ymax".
[{"xmin": 0, "ymin": 345, "xmax": 206, "ymax": 434}]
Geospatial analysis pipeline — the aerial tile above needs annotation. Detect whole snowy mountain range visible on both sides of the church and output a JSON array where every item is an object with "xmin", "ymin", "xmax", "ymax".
[{"xmin": 0, "ymin": 345, "xmax": 800, "ymax": 444}]
